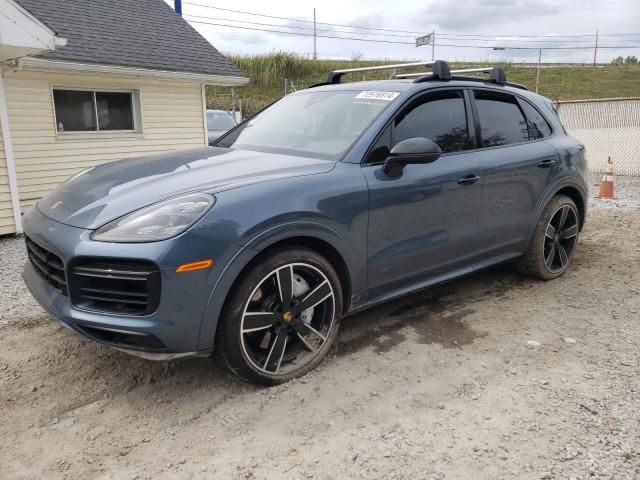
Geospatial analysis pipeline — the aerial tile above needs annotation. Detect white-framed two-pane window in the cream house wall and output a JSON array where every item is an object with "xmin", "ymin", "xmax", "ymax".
[{"xmin": 53, "ymin": 88, "xmax": 136, "ymax": 135}]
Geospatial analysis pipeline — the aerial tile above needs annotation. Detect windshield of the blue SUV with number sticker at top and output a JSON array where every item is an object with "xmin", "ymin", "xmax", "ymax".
[{"xmin": 218, "ymin": 91, "xmax": 398, "ymax": 160}]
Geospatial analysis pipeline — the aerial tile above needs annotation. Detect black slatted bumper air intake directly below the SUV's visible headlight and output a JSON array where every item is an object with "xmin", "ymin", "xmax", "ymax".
[{"xmin": 69, "ymin": 260, "xmax": 160, "ymax": 315}]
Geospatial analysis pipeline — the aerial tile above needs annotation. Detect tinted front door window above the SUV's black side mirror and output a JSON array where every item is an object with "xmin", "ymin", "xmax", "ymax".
[{"xmin": 393, "ymin": 91, "xmax": 469, "ymax": 153}]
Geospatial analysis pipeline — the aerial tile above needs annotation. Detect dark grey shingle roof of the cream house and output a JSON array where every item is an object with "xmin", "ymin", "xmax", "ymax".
[{"xmin": 16, "ymin": 0, "xmax": 243, "ymax": 77}]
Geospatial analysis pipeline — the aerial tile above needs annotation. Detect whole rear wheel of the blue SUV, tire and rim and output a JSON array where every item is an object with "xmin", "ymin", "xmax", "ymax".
[{"xmin": 517, "ymin": 195, "xmax": 580, "ymax": 280}]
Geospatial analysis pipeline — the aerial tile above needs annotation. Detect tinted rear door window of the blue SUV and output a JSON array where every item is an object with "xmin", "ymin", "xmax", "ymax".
[{"xmin": 475, "ymin": 91, "xmax": 529, "ymax": 147}]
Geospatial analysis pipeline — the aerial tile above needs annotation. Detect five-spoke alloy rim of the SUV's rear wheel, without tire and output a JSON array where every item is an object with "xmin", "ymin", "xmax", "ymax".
[{"xmin": 543, "ymin": 205, "xmax": 579, "ymax": 273}]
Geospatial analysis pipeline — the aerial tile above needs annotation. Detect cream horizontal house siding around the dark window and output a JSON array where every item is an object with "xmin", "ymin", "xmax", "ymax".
[{"xmin": 0, "ymin": 71, "xmax": 206, "ymax": 227}]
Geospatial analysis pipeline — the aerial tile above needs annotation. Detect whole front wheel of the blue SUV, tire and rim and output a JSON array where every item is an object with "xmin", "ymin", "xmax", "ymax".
[{"xmin": 216, "ymin": 246, "xmax": 343, "ymax": 385}]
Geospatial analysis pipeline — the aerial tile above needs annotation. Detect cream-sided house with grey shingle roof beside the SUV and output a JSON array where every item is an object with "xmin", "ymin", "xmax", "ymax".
[{"xmin": 0, "ymin": 0, "xmax": 248, "ymax": 235}]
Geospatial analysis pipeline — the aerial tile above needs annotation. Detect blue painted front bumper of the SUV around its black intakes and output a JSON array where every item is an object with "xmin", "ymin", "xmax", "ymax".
[{"xmin": 23, "ymin": 208, "xmax": 230, "ymax": 359}]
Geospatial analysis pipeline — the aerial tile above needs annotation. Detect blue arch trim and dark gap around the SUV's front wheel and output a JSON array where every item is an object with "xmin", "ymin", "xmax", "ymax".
[{"xmin": 198, "ymin": 223, "xmax": 355, "ymax": 350}]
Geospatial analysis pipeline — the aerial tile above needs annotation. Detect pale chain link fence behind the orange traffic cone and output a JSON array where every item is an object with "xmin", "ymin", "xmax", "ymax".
[{"xmin": 557, "ymin": 97, "xmax": 640, "ymax": 176}]
